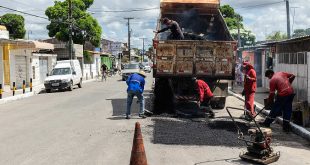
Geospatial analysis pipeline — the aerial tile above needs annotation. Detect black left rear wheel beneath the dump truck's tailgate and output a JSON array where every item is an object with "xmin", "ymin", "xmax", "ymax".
[{"xmin": 154, "ymin": 78, "xmax": 175, "ymax": 114}]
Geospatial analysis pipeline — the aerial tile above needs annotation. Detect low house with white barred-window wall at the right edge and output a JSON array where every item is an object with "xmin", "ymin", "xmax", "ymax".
[{"xmin": 265, "ymin": 36, "xmax": 310, "ymax": 125}]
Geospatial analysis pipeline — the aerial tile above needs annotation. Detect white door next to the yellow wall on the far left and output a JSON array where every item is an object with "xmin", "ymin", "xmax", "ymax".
[{"xmin": 15, "ymin": 56, "xmax": 28, "ymax": 89}]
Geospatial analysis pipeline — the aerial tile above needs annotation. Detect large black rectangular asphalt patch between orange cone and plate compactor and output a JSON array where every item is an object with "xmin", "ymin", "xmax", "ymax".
[{"xmin": 153, "ymin": 118, "xmax": 249, "ymax": 147}]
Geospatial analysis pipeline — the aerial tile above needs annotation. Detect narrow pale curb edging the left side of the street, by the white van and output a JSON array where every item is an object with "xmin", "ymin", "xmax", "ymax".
[{"xmin": 0, "ymin": 79, "xmax": 96, "ymax": 105}]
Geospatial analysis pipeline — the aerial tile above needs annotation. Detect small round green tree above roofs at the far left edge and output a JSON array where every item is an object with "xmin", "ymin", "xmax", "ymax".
[{"xmin": 0, "ymin": 14, "xmax": 26, "ymax": 39}]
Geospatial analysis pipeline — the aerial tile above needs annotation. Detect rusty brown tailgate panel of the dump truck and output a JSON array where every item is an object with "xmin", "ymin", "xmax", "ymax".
[{"xmin": 154, "ymin": 40, "xmax": 236, "ymax": 79}]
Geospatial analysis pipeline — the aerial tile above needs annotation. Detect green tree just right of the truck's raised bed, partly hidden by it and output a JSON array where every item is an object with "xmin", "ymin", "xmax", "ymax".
[{"xmin": 220, "ymin": 5, "xmax": 256, "ymax": 47}]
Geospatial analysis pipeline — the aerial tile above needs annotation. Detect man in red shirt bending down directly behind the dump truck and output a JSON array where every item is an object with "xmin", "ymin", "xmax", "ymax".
[{"xmin": 193, "ymin": 77, "xmax": 214, "ymax": 118}]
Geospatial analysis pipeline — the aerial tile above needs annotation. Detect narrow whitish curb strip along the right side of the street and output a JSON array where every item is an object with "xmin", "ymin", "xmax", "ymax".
[{"xmin": 228, "ymin": 89, "xmax": 310, "ymax": 141}]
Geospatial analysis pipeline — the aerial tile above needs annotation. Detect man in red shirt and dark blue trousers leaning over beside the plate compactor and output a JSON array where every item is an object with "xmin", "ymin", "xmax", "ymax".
[{"xmin": 260, "ymin": 70, "xmax": 295, "ymax": 132}]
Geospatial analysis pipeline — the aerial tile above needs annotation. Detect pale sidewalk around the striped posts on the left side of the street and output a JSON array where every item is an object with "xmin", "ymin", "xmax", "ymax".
[{"xmin": 0, "ymin": 79, "xmax": 96, "ymax": 104}]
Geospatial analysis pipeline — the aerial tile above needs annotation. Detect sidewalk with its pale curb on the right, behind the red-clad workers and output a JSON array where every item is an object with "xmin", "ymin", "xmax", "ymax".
[{"xmin": 229, "ymin": 86, "xmax": 310, "ymax": 141}]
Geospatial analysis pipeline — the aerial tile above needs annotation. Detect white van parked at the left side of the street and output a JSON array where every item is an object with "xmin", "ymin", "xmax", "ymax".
[{"xmin": 44, "ymin": 60, "xmax": 83, "ymax": 93}]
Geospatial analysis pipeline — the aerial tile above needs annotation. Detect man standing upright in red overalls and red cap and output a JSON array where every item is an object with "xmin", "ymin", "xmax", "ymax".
[{"xmin": 242, "ymin": 62, "xmax": 256, "ymax": 118}]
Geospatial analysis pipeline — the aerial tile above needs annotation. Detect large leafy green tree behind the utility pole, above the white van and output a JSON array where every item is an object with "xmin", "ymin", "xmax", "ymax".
[{"xmin": 45, "ymin": 0, "xmax": 102, "ymax": 46}]
